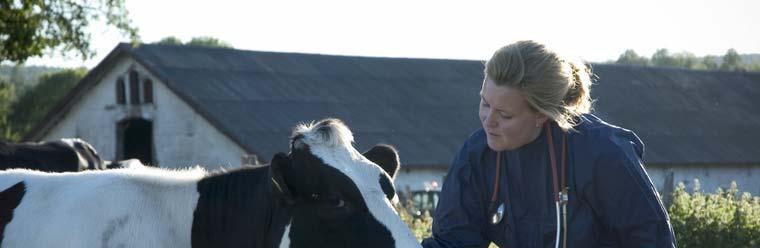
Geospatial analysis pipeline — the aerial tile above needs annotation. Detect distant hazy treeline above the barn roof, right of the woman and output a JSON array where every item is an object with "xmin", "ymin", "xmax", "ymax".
[{"xmin": 610, "ymin": 48, "xmax": 760, "ymax": 72}]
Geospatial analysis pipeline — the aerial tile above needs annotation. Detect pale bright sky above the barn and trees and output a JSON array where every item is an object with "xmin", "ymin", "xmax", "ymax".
[{"xmin": 17, "ymin": 0, "xmax": 760, "ymax": 68}]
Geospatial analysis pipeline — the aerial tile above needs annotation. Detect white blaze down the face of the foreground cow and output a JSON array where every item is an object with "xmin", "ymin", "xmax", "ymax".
[{"xmin": 291, "ymin": 119, "xmax": 419, "ymax": 247}]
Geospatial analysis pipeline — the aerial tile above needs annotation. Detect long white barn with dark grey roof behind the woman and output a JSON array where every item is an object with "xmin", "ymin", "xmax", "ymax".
[{"xmin": 25, "ymin": 44, "xmax": 760, "ymax": 209}]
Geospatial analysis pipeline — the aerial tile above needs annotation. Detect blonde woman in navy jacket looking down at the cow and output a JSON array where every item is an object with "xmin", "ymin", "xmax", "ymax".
[{"xmin": 422, "ymin": 41, "xmax": 676, "ymax": 248}]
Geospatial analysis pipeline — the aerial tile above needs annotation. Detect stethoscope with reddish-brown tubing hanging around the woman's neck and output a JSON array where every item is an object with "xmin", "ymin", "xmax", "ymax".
[{"xmin": 488, "ymin": 122, "xmax": 568, "ymax": 248}]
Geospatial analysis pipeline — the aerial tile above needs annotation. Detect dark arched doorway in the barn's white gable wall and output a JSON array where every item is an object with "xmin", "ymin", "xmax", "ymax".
[{"xmin": 116, "ymin": 119, "xmax": 156, "ymax": 166}]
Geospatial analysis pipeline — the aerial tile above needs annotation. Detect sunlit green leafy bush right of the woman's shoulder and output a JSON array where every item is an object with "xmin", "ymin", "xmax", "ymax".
[{"xmin": 668, "ymin": 180, "xmax": 760, "ymax": 248}]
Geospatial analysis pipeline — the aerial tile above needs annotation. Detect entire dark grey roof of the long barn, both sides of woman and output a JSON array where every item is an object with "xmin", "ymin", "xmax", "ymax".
[{"xmin": 28, "ymin": 44, "xmax": 760, "ymax": 167}]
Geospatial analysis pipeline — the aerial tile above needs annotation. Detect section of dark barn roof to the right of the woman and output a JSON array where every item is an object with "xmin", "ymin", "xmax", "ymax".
[{"xmin": 592, "ymin": 65, "xmax": 760, "ymax": 164}]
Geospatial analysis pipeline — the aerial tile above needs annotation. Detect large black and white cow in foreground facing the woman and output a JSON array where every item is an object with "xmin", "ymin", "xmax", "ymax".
[{"xmin": 0, "ymin": 119, "xmax": 420, "ymax": 248}]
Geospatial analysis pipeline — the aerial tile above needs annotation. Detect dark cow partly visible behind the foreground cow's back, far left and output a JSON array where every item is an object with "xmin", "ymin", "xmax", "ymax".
[{"xmin": 0, "ymin": 138, "xmax": 106, "ymax": 172}]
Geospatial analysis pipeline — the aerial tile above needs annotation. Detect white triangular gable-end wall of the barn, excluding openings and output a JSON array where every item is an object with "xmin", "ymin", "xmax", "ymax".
[{"xmin": 43, "ymin": 58, "xmax": 245, "ymax": 169}]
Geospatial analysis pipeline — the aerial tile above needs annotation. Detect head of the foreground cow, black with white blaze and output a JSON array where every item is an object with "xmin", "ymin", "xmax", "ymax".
[{"xmin": 271, "ymin": 119, "xmax": 419, "ymax": 247}]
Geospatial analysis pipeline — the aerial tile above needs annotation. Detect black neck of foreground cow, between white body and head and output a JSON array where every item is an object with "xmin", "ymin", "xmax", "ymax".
[{"xmin": 192, "ymin": 167, "xmax": 290, "ymax": 247}]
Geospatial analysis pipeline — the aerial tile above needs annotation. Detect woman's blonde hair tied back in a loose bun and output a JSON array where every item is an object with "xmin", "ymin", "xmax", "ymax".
[{"xmin": 485, "ymin": 41, "xmax": 593, "ymax": 130}]
